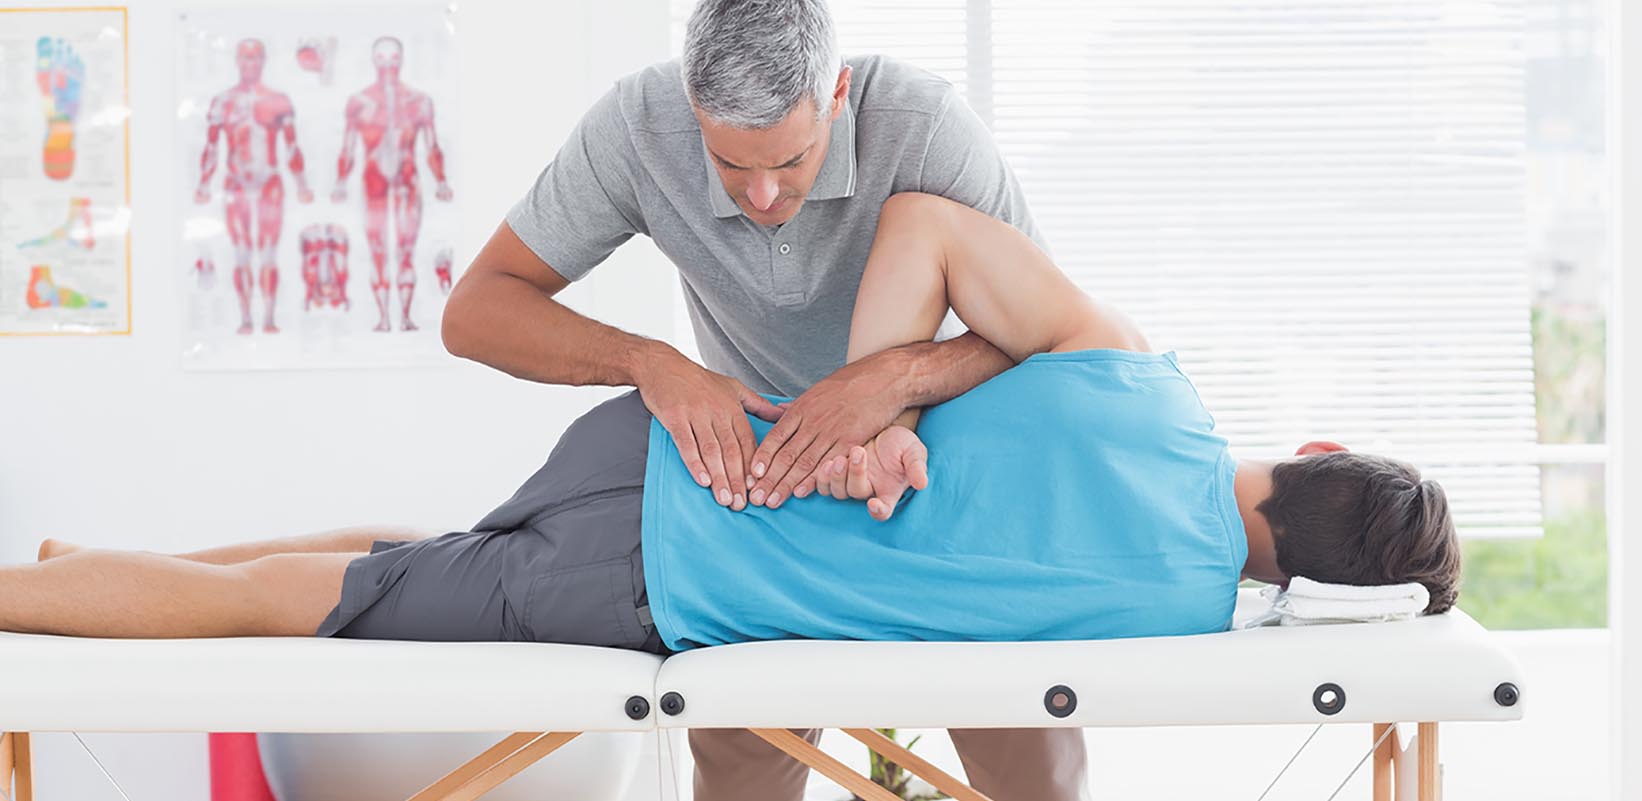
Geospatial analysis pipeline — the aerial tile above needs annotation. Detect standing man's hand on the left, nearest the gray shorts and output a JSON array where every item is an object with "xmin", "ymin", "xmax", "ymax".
[{"xmin": 637, "ymin": 351, "xmax": 782, "ymax": 510}]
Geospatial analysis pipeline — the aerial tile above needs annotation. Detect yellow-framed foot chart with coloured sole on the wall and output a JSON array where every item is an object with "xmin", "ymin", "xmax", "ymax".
[{"xmin": 0, "ymin": 8, "xmax": 131, "ymax": 335}]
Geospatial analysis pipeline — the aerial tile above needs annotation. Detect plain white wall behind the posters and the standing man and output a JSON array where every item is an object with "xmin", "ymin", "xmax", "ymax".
[{"xmin": 0, "ymin": 0, "xmax": 675, "ymax": 801}]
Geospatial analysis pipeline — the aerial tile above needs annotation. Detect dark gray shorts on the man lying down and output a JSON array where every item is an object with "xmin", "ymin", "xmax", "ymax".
[{"xmin": 315, "ymin": 391, "xmax": 668, "ymax": 653}]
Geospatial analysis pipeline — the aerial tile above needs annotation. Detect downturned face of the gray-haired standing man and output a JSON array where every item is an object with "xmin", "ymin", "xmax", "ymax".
[{"xmin": 696, "ymin": 67, "xmax": 849, "ymax": 225}]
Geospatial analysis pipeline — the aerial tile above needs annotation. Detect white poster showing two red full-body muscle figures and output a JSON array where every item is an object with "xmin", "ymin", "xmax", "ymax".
[{"xmin": 176, "ymin": 5, "xmax": 461, "ymax": 369}]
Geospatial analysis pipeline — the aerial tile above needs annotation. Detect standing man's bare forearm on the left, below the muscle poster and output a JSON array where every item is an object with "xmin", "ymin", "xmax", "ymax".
[{"xmin": 443, "ymin": 272, "xmax": 677, "ymax": 386}]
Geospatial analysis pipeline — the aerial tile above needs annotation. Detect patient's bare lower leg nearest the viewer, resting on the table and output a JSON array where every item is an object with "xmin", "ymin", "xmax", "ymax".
[{"xmin": 0, "ymin": 550, "xmax": 356, "ymax": 637}]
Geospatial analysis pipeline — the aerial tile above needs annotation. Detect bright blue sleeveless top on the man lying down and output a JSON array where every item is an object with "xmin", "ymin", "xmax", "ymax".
[{"xmin": 644, "ymin": 350, "xmax": 1248, "ymax": 650}]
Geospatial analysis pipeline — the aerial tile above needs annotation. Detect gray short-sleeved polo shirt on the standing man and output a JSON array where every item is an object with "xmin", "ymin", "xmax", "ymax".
[{"xmin": 507, "ymin": 56, "xmax": 1044, "ymax": 396}]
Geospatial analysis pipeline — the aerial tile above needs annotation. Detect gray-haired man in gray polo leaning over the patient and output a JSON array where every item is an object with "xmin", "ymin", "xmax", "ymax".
[{"xmin": 443, "ymin": 0, "xmax": 1087, "ymax": 801}]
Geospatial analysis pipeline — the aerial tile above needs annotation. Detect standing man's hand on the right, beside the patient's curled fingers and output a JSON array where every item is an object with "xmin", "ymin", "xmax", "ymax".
[{"xmin": 747, "ymin": 350, "xmax": 906, "ymax": 509}]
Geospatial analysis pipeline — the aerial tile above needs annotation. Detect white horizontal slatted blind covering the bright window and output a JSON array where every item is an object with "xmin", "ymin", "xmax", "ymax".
[{"xmin": 673, "ymin": 0, "xmax": 1540, "ymax": 537}]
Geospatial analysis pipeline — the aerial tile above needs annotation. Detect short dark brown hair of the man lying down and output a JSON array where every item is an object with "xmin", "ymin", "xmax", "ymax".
[{"xmin": 1256, "ymin": 451, "xmax": 1460, "ymax": 614}]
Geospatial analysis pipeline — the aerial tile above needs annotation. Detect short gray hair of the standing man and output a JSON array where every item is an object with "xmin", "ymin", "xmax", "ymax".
[{"xmin": 681, "ymin": 0, "xmax": 839, "ymax": 128}]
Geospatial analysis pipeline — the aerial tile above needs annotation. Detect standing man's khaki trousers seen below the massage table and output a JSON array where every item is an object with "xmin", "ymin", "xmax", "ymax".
[{"xmin": 690, "ymin": 729, "xmax": 1089, "ymax": 801}]
